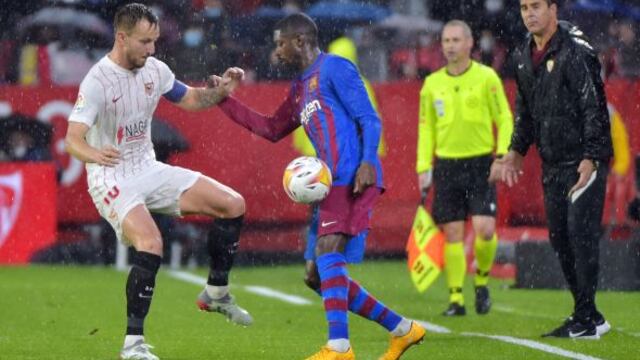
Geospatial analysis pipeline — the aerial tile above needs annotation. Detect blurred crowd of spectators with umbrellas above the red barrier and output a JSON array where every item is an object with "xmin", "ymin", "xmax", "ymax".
[{"xmin": 0, "ymin": 0, "xmax": 640, "ymax": 85}]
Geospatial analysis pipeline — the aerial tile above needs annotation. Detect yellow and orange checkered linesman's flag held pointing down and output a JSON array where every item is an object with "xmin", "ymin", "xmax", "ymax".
[{"xmin": 406, "ymin": 197, "xmax": 446, "ymax": 293}]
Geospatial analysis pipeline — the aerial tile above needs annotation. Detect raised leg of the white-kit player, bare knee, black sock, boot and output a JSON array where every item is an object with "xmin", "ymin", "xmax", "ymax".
[{"xmin": 180, "ymin": 176, "xmax": 253, "ymax": 326}]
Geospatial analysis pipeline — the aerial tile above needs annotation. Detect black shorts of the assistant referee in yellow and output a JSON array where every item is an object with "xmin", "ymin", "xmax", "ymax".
[{"xmin": 432, "ymin": 155, "xmax": 497, "ymax": 224}]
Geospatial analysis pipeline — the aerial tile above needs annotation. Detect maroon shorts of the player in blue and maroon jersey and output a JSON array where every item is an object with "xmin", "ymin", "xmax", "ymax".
[{"xmin": 318, "ymin": 186, "xmax": 381, "ymax": 237}]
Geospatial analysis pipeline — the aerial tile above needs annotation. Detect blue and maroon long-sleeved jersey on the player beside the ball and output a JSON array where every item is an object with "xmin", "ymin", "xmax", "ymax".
[{"xmin": 220, "ymin": 53, "xmax": 383, "ymax": 188}]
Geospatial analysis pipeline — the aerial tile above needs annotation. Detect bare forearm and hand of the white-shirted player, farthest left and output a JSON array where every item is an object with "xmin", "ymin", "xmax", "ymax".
[{"xmin": 64, "ymin": 121, "xmax": 120, "ymax": 167}]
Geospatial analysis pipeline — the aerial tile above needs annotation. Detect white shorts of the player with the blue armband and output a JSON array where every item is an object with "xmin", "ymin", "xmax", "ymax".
[{"xmin": 89, "ymin": 161, "xmax": 202, "ymax": 244}]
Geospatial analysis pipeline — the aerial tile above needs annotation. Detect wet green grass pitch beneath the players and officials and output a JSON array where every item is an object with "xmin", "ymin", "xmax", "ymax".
[{"xmin": 0, "ymin": 261, "xmax": 640, "ymax": 360}]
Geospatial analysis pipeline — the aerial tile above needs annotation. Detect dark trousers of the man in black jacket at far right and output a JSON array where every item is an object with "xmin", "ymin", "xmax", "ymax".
[{"xmin": 542, "ymin": 164, "xmax": 608, "ymax": 320}]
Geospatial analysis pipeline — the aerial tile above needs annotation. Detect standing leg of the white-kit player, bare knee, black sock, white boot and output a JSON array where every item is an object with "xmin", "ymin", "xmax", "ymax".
[{"xmin": 120, "ymin": 204, "xmax": 162, "ymax": 360}]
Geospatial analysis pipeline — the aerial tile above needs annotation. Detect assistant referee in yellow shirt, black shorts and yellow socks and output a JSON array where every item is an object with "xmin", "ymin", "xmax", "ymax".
[{"xmin": 416, "ymin": 20, "xmax": 513, "ymax": 316}]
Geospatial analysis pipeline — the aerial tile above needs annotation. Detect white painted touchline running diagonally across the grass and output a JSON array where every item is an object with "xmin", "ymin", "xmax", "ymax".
[{"xmin": 168, "ymin": 270, "xmax": 602, "ymax": 360}]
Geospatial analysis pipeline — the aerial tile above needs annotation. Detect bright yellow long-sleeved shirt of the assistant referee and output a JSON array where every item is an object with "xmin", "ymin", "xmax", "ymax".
[{"xmin": 416, "ymin": 61, "xmax": 513, "ymax": 173}]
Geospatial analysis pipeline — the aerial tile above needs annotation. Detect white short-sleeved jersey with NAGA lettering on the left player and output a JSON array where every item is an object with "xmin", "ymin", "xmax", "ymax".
[{"xmin": 69, "ymin": 56, "xmax": 175, "ymax": 188}]
